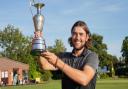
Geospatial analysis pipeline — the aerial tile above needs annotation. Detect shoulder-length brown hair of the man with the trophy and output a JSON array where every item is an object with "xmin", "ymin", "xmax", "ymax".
[{"xmin": 68, "ymin": 21, "xmax": 92, "ymax": 48}]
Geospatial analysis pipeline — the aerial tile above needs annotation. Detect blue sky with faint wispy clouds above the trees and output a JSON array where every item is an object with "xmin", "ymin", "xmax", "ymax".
[{"xmin": 0, "ymin": 0, "xmax": 128, "ymax": 57}]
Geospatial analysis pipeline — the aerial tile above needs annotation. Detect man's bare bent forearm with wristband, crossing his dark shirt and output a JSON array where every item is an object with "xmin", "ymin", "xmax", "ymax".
[{"xmin": 57, "ymin": 57, "xmax": 96, "ymax": 86}]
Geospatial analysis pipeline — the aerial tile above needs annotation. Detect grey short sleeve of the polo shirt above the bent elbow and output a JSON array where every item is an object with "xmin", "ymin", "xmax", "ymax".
[{"xmin": 86, "ymin": 52, "xmax": 99, "ymax": 70}]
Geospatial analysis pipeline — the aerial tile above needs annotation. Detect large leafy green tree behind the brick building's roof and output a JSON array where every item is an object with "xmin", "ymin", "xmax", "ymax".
[{"xmin": 0, "ymin": 25, "xmax": 31, "ymax": 62}]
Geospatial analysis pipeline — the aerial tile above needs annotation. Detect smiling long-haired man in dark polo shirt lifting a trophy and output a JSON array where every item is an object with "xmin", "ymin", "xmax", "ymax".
[{"xmin": 39, "ymin": 21, "xmax": 99, "ymax": 89}]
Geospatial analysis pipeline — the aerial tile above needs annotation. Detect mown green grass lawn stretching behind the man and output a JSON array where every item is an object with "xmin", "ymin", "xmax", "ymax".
[{"xmin": 0, "ymin": 79, "xmax": 128, "ymax": 89}]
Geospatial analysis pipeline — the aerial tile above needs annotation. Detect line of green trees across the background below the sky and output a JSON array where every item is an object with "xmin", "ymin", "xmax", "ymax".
[{"xmin": 0, "ymin": 25, "xmax": 128, "ymax": 81}]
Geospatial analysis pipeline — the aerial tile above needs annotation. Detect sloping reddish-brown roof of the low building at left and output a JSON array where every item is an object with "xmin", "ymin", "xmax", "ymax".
[{"xmin": 0, "ymin": 57, "xmax": 29, "ymax": 70}]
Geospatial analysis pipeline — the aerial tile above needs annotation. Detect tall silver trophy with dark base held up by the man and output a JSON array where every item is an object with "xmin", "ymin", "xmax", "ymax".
[{"xmin": 31, "ymin": 0, "xmax": 46, "ymax": 56}]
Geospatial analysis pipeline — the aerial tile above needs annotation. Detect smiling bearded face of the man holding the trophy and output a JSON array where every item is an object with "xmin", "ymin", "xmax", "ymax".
[{"xmin": 72, "ymin": 26, "xmax": 89, "ymax": 50}]
